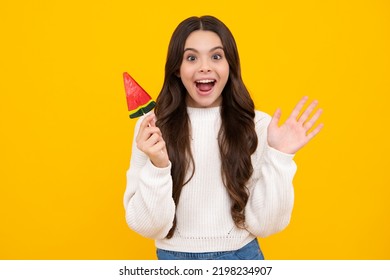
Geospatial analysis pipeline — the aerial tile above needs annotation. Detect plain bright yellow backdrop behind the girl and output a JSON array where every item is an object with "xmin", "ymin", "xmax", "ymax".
[{"xmin": 0, "ymin": 0, "xmax": 390, "ymax": 259}]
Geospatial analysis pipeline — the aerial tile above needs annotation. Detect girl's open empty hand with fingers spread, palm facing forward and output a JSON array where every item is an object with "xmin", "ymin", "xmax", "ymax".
[{"xmin": 268, "ymin": 96, "xmax": 324, "ymax": 154}]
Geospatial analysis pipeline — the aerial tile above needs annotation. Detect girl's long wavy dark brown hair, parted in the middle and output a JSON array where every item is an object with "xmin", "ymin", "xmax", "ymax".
[{"xmin": 155, "ymin": 16, "xmax": 257, "ymax": 238}]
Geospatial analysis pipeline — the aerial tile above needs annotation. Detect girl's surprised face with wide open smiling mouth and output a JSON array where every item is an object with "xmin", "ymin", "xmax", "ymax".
[{"xmin": 179, "ymin": 30, "xmax": 229, "ymax": 108}]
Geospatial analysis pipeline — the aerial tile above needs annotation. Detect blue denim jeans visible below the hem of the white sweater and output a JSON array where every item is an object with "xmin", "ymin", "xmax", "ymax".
[{"xmin": 157, "ymin": 238, "xmax": 264, "ymax": 260}]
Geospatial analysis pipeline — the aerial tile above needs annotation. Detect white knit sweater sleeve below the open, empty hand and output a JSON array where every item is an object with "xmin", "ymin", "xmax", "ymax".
[{"xmin": 245, "ymin": 113, "xmax": 297, "ymax": 237}]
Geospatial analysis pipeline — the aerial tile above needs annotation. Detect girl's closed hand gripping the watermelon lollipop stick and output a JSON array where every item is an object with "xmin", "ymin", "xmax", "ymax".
[{"xmin": 136, "ymin": 114, "xmax": 169, "ymax": 168}]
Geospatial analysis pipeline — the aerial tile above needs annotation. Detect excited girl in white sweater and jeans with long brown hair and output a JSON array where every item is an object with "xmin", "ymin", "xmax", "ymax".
[{"xmin": 124, "ymin": 16, "xmax": 322, "ymax": 259}]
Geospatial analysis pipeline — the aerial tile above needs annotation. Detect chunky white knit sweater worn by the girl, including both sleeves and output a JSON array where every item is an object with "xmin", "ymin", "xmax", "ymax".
[{"xmin": 124, "ymin": 107, "xmax": 296, "ymax": 252}]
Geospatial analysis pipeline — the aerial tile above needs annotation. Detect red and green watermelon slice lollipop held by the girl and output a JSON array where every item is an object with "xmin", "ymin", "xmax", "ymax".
[{"xmin": 123, "ymin": 72, "xmax": 156, "ymax": 119}]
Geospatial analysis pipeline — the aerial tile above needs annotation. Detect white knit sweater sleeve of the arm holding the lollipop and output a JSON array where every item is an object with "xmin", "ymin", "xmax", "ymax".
[{"xmin": 123, "ymin": 118, "xmax": 175, "ymax": 239}]
